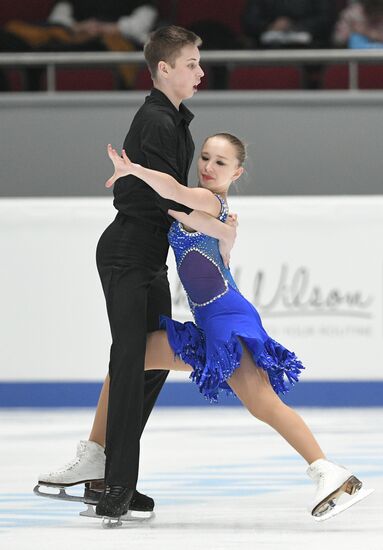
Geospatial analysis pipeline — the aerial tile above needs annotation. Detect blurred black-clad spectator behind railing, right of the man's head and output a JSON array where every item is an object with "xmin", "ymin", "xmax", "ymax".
[{"xmin": 243, "ymin": 0, "xmax": 334, "ymax": 89}]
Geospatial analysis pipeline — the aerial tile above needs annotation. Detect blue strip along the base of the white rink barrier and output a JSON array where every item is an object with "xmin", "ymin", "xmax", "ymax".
[{"xmin": 0, "ymin": 380, "xmax": 383, "ymax": 408}]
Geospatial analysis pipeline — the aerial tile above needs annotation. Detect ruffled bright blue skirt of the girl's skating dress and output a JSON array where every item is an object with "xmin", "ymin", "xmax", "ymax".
[{"xmin": 161, "ymin": 287, "xmax": 304, "ymax": 402}]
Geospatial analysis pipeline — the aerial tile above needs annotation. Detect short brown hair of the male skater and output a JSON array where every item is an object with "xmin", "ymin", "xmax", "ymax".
[{"xmin": 144, "ymin": 25, "xmax": 202, "ymax": 78}]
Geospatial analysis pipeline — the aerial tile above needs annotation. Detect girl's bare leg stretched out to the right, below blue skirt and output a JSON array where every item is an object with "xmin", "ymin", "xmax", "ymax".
[{"xmin": 228, "ymin": 346, "xmax": 325, "ymax": 464}]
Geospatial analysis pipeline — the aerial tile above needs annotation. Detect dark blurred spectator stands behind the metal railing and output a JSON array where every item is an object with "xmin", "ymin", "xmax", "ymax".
[{"xmin": 0, "ymin": 0, "xmax": 383, "ymax": 91}]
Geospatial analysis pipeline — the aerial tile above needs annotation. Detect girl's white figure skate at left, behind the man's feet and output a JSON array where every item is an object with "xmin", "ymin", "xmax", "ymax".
[{"xmin": 33, "ymin": 441, "xmax": 105, "ymax": 502}]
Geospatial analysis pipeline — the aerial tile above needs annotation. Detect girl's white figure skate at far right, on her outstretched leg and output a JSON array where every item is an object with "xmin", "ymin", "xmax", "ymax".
[{"xmin": 307, "ymin": 458, "xmax": 374, "ymax": 521}]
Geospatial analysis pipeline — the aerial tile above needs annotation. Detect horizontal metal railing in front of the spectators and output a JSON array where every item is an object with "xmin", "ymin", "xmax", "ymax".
[{"xmin": 0, "ymin": 49, "xmax": 383, "ymax": 92}]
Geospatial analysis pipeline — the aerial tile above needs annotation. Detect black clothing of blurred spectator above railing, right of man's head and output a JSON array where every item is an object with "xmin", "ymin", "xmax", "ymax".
[{"xmin": 243, "ymin": 0, "xmax": 334, "ymax": 42}]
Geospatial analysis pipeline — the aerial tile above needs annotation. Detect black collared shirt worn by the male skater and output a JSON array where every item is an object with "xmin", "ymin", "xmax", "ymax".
[{"xmin": 113, "ymin": 88, "xmax": 194, "ymax": 231}]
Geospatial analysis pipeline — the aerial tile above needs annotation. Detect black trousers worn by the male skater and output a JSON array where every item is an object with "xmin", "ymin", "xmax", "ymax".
[{"xmin": 96, "ymin": 214, "xmax": 171, "ymax": 489}]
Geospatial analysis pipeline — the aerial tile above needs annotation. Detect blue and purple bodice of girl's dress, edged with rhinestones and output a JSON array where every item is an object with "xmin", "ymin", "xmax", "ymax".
[{"xmin": 168, "ymin": 195, "xmax": 237, "ymax": 312}]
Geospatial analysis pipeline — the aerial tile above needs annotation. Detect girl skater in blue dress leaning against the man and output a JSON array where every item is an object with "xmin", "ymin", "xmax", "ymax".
[{"xmin": 40, "ymin": 133, "xmax": 367, "ymax": 520}]
